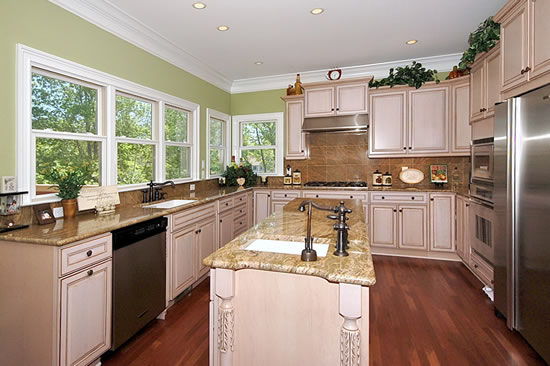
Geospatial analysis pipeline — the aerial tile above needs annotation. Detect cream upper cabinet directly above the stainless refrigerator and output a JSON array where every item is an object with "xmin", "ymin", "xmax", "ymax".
[{"xmin": 494, "ymin": 0, "xmax": 550, "ymax": 99}]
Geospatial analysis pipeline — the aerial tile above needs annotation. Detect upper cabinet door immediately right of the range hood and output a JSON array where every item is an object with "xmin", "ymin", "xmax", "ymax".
[{"xmin": 369, "ymin": 92, "xmax": 407, "ymax": 156}]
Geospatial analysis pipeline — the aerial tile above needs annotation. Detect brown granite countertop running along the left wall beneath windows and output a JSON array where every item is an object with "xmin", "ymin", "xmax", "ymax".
[{"xmin": 0, "ymin": 187, "xmax": 251, "ymax": 246}]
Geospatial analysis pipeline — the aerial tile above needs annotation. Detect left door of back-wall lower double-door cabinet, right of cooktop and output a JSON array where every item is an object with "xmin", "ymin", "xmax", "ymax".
[{"xmin": 369, "ymin": 204, "xmax": 397, "ymax": 248}]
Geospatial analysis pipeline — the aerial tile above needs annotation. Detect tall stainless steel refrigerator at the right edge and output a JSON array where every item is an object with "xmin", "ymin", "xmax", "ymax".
[{"xmin": 494, "ymin": 85, "xmax": 550, "ymax": 363}]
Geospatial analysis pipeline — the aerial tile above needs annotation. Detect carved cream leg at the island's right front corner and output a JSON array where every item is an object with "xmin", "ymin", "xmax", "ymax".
[{"xmin": 339, "ymin": 283, "xmax": 368, "ymax": 366}]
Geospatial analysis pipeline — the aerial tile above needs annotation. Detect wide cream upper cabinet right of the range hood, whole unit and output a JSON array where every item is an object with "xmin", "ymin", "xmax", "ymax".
[{"xmin": 369, "ymin": 77, "xmax": 470, "ymax": 157}]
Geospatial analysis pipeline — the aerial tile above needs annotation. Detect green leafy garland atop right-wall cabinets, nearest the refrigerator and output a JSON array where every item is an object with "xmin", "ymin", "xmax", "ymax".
[{"xmin": 458, "ymin": 17, "xmax": 500, "ymax": 70}]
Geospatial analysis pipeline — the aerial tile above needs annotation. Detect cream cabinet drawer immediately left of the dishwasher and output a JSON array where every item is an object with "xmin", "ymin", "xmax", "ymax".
[{"xmin": 59, "ymin": 233, "xmax": 113, "ymax": 277}]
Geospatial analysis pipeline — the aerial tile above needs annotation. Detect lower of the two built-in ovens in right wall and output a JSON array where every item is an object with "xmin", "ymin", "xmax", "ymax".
[{"xmin": 469, "ymin": 197, "xmax": 495, "ymax": 264}]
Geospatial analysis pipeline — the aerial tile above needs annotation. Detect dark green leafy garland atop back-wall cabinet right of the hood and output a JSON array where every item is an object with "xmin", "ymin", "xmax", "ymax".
[{"xmin": 369, "ymin": 61, "xmax": 439, "ymax": 89}]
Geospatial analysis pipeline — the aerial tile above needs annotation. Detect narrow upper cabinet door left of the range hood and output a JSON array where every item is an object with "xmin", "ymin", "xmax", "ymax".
[{"xmin": 285, "ymin": 100, "xmax": 306, "ymax": 160}]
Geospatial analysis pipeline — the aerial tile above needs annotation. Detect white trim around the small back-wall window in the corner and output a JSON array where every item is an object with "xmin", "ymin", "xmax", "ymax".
[{"xmin": 231, "ymin": 112, "xmax": 284, "ymax": 176}]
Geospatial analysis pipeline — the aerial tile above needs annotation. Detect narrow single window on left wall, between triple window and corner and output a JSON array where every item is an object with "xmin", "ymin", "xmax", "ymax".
[{"xmin": 206, "ymin": 109, "xmax": 231, "ymax": 178}]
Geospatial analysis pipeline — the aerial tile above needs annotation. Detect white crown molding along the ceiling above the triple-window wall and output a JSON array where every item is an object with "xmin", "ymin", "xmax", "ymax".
[{"xmin": 49, "ymin": 0, "xmax": 235, "ymax": 92}]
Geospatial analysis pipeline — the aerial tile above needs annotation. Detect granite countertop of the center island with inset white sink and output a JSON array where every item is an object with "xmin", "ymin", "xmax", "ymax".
[{"xmin": 203, "ymin": 198, "xmax": 376, "ymax": 286}]
